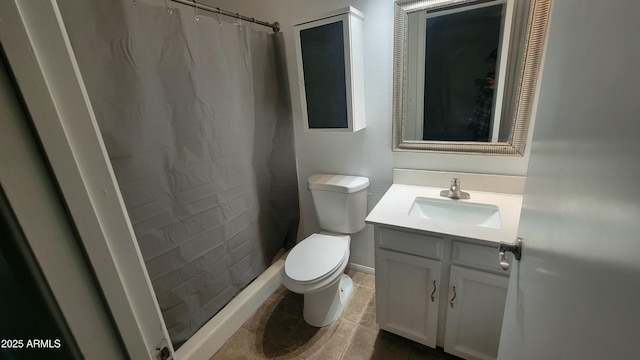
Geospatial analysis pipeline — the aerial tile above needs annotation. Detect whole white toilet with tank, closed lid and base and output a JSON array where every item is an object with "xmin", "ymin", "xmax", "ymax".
[{"xmin": 282, "ymin": 174, "xmax": 369, "ymax": 327}]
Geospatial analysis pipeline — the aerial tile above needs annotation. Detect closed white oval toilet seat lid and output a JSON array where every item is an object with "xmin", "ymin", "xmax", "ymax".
[{"xmin": 284, "ymin": 234, "xmax": 349, "ymax": 284}]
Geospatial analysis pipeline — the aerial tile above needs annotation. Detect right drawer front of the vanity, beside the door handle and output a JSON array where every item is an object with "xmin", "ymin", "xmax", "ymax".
[{"xmin": 452, "ymin": 241, "xmax": 509, "ymax": 276}]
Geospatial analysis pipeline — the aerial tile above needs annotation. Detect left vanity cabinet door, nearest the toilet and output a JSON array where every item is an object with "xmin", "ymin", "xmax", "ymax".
[{"xmin": 376, "ymin": 249, "xmax": 442, "ymax": 347}]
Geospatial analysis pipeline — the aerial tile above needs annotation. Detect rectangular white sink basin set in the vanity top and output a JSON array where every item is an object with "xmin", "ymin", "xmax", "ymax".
[{"xmin": 409, "ymin": 197, "xmax": 502, "ymax": 229}]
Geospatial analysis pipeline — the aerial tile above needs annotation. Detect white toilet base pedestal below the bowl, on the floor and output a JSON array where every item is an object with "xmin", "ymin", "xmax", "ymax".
[{"xmin": 303, "ymin": 274, "xmax": 353, "ymax": 327}]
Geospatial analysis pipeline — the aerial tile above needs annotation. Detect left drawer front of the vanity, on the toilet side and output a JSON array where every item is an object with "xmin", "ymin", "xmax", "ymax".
[{"xmin": 378, "ymin": 228, "xmax": 442, "ymax": 259}]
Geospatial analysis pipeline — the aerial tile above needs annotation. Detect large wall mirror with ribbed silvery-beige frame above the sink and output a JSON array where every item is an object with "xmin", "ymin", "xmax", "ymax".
[{"xmin": 393, "ymin": 0, "xmax": 551, "ymax": 156}]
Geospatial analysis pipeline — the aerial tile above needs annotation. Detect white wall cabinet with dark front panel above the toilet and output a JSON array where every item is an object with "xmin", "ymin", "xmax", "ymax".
[{"xmin": 294, "ymin": 7, "xmax": 365, "ymax": 132}]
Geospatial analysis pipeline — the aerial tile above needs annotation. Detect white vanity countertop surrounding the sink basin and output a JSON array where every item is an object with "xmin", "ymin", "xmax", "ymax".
[{"xmin": 366, "ymin": 184, "xmax": 522, "ymax": 243}]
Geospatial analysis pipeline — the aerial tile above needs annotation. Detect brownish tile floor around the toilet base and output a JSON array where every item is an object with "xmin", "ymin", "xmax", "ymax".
[{"xmin": 211, "ymin": 270, "xmax": 459, "ymax": 360}]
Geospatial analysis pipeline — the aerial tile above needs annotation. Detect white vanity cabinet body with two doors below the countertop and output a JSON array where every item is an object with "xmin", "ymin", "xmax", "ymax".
[{"xmin": 374, "ymin": 225, "xmax": 509, "ymax": 359}]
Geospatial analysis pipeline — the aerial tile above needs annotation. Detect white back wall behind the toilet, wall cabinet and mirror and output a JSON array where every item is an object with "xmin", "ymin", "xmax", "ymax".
[{"xmin": 208, "ymin": 0, "xmax": 528, "ymax": 267}]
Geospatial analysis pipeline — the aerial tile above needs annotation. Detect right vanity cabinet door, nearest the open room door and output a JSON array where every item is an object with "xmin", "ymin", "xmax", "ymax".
[{"xmin": 444, "ymin": 266, "xmax": 509, "ymax": 360}]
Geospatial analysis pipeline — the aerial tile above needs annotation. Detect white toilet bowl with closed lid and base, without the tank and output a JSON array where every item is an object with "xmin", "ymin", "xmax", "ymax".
[{"xmin": 282, "ymin": 233, "xmax": 353, "ymax": 327}]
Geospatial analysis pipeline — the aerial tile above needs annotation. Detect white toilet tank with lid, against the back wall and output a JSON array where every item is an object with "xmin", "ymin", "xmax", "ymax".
[{"xmin": 308, "ymin": 174, "xmax": 369, "ymax": 234}]
